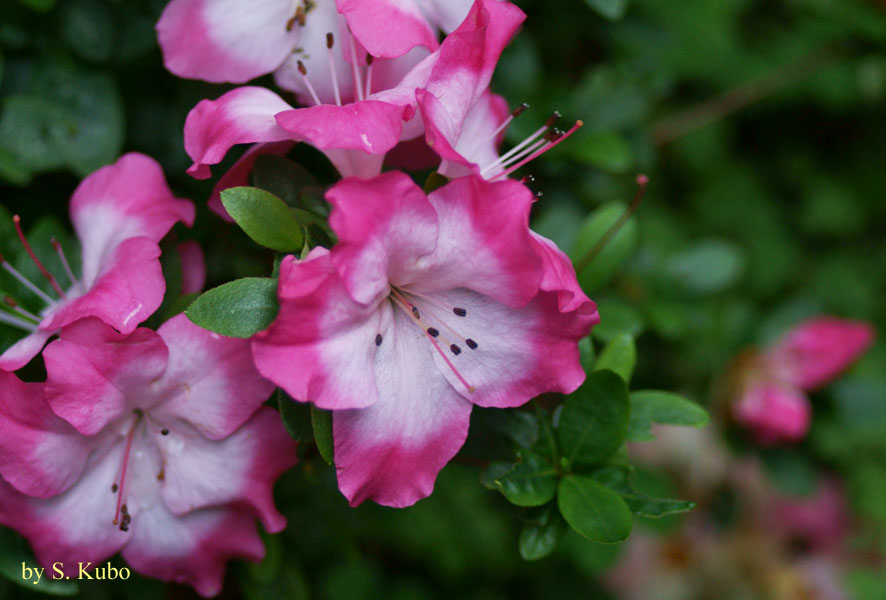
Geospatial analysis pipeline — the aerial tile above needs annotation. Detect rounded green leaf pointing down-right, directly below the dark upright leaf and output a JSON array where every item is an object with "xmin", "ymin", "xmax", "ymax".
[{"xmin": 557, "ymin": 475, "xmax": 631, "ymax": 544}]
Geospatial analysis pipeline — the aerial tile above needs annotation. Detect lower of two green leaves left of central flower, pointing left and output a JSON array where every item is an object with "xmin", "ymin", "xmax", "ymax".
[{"xmin": 185, "ymin": 277, "xmax": 279, "ymax": 338}]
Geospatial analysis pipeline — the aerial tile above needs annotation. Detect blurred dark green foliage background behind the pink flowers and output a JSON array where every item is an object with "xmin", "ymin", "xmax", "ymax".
[{"xmin": 0, "ymin": 0, "xmax": 886, "ymax": 600}]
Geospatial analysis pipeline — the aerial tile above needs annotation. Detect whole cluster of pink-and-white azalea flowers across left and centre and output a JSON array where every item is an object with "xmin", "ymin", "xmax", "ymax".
[{"xmin": 0, "ymin": 0, "xmax": 599, "ymax": 595}]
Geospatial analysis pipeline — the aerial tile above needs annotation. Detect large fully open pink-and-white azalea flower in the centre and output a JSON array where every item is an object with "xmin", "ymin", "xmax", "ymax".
[{"xmin": 253, "ymin": 172, "xmax": 599, "ymax": 507}]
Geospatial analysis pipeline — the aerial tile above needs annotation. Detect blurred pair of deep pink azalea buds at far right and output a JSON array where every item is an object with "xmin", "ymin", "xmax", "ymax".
[{"xmin": 732, "ymin": 317, "xmax": 874, "ymax": 444}]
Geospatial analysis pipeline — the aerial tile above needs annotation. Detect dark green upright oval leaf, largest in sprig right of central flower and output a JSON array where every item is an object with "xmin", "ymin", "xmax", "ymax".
[{"xmin": 557, "ymin": 371, "xmax": 630, "ymax": 466}]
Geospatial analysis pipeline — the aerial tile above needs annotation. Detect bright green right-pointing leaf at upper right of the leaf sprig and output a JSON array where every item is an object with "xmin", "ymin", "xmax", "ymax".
[{"xmin": 628, "ymin": 390, "xmax": 710, "ymax": 442}]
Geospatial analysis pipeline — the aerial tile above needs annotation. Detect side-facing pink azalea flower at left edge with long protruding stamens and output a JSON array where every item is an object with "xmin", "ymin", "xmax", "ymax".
[{"xmin": 0, "ymin": 154, "xmax": 194, "ymax": 371}]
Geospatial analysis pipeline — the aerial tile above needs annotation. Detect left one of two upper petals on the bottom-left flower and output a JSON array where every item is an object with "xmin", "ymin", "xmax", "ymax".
[{"xmin": 43, "ymin": 319, "xmax": 169, "ymax": 435}]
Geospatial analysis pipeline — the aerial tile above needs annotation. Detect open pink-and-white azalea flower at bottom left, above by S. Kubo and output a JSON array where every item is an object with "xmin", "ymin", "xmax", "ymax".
[{"xmin": 0, "ymin": 315, "xmax": 295, "ymax": 596}]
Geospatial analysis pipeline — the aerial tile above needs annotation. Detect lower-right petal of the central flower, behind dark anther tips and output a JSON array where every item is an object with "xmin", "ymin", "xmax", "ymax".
[{"xmin": 424, "ymin": 289, "xmax": 599, "ymax": 408}]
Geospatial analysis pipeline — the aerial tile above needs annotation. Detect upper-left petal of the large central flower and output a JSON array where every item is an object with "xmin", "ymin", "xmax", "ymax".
[{"xmin": 326, "ymin": 172, "xmax": 439, "ymax": 304}]
